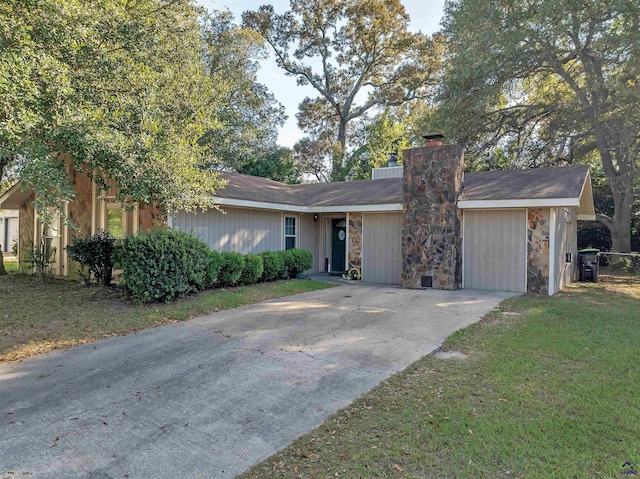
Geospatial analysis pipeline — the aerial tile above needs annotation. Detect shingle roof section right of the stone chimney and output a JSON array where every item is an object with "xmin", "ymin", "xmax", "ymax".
[{"xmin": 460, "ymin": 166, "xmax": 589, "ymax": 201}]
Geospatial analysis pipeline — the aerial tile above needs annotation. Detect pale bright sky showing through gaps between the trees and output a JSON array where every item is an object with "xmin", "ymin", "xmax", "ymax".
[{"xmin": 197, "ymin": 0, "xmax": 444, "ymax": 147}]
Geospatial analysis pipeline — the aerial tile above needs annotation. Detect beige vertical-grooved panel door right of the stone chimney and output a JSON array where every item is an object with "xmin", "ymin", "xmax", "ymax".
[{"xmin": 462, "ymin": 210, "xmax": 527, "ymax": 292}]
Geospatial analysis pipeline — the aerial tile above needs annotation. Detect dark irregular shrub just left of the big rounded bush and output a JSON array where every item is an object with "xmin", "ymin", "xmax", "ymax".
[{"xmin": 66, "ymin": 230, "xmax": 116, "ymax": 286}]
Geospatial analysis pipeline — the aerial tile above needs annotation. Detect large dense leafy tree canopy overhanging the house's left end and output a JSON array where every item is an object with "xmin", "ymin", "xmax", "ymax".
[{"xmin": 0, "ymin": 0, "xmax": 225, "ymax": 221}]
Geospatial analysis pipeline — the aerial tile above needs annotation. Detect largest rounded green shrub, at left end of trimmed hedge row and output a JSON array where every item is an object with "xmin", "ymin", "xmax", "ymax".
[{"xmin": 114, "ymin": 229, "xmax": 210, "ymax": 303}]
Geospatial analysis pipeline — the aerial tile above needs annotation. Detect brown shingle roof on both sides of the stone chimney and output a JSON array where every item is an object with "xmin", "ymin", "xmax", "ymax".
[{"xmin": 216, "ymin": 166, "xmax": 589, "ymax": 206}]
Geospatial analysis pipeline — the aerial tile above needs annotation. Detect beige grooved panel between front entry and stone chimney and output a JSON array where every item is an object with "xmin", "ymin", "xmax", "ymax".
[{"xmin": 362, "ymin": 213, "xmax": 402, "ymax": 284}]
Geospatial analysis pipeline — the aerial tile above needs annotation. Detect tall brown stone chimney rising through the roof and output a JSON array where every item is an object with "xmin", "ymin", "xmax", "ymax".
[{"xmin": 402, "ymin": 145, "xmax": 463, "ymax": 290}]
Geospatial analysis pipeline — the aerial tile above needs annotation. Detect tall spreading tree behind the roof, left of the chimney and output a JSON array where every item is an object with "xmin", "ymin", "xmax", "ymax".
[{"xmin": 243, "ymin": 0, "xmax": 441, "ymax": 181}]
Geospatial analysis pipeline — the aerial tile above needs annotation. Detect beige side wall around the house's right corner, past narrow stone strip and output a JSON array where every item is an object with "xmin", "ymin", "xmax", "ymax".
[{"xmin": 550, "ymin": 208, "xmax": 578, "ymax": 294}]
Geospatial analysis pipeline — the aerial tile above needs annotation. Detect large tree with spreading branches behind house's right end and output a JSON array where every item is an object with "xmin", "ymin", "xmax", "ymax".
[{"xmin": 440, "ymin": 0, "xmax": 640, "ymax": 252}]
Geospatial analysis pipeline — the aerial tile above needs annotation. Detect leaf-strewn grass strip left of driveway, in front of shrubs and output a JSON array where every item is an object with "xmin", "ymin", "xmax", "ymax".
[{"xmin": 0, "ymin": 276, "xmax": 333, "ymax": 362}]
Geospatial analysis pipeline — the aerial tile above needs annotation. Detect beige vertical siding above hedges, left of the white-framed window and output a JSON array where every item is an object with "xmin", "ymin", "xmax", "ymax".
[{"xmin": 173, "ymin": 208, "xmax": 284, "ymax": 254}]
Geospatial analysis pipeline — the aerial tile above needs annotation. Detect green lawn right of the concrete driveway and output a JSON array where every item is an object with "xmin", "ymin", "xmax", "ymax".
[{"xmin": 241, "ymin": 283, "xmax": 640, "ymax": 479}]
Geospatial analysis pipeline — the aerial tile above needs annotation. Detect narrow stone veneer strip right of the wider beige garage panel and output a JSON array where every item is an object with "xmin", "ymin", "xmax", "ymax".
[{"xmin": 527, "ymin": 208, "xmax": 551, "ymax": 294}]
